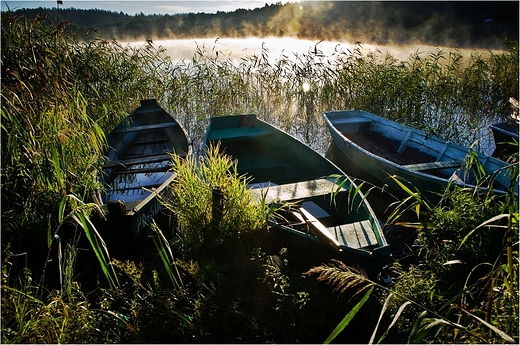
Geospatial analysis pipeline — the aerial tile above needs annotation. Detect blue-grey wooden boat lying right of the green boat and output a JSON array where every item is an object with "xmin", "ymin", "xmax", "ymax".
[{"xmin": 323, "ymin": 110, "xmax": 511, "ymax": 202}]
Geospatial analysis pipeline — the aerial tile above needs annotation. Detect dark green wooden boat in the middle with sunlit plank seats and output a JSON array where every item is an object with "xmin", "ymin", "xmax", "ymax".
[{"xmin": 204, "ymin": 115, "xmax": 390, "ymax": 275}]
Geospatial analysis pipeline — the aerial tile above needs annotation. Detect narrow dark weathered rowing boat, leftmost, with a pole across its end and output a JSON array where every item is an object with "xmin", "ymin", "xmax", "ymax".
[{"xmin": 101, "ymin": 99, "xmax": 191, "ymax": 236}]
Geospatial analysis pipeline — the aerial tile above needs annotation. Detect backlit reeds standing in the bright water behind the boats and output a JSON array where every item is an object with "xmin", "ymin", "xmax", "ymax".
[{"xmin": 167, "ymin": 43, "xmax": 518, "ymax": 152}]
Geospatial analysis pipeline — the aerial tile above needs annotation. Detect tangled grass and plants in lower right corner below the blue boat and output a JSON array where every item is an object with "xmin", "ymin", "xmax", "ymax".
[{"xmin": 352, "ymin": 165, "xmax": 519, "ymax": 343}]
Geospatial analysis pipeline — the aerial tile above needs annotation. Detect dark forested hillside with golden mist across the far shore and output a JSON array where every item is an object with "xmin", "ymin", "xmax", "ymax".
[{"xmin": 7, "ymin": 1, "xmax": 519, "ymax": 49}]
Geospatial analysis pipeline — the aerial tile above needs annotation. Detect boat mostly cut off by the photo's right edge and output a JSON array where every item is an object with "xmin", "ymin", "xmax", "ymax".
[{"xmin": 490, "ymin": 116, "xmax": 519, "ymax": 159}]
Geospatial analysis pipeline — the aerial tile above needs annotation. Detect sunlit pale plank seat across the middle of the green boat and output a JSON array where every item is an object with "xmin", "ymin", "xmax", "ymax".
[{"xmin": 254, "ymin": 179, "xmax": 344, "ymax": 203}]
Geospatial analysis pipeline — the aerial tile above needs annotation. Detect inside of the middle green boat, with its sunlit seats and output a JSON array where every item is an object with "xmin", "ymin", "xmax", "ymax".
[{"xmin": 208, "ymin": 119, "xmax": 386, "ymax": 250}]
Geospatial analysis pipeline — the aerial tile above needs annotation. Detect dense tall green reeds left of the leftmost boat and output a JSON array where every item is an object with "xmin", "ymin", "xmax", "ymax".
[{"xmin": 1, "ymin": 12, "xmax": 171, "ymax": 343}]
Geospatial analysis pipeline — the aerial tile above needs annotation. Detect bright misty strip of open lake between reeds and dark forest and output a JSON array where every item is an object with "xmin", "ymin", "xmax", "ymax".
[{"xmin": 124, "ymin": 37, "xmax": 499, "ymax": 63}]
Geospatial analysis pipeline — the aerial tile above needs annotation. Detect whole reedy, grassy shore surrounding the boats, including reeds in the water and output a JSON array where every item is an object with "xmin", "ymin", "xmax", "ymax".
[{"xmin": 1, "ymin": 13, "xmax": 519, "ymax": 343}]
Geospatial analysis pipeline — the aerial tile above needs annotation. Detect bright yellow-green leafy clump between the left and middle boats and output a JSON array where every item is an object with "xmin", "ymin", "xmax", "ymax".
[{"xmin": 161, "ymin": 145, "xmax": 266, "ymax": 259}]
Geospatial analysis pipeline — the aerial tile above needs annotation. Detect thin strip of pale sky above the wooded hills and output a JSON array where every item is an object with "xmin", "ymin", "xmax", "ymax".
[{"xmin": 1, "ymin": 0, "xmax": 297, "ymax": 15}]
